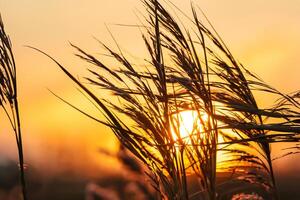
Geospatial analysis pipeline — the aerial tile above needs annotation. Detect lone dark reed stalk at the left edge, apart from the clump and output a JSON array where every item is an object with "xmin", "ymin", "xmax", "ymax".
[{"xmin": 0, "ymin": 15, "xmax": 27, "ymax": 200}]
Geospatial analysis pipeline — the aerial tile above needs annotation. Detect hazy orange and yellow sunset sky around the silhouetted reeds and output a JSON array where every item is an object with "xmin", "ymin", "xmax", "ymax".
[{"xmin": 0, "ymin": 0, "xmax": 300, "ymax": 176}]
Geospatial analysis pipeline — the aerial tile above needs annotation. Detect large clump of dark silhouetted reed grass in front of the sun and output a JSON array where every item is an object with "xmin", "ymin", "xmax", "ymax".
[{"xmin": 31, "ymin": 0, "xmax": 300, "ymax": 200}]
